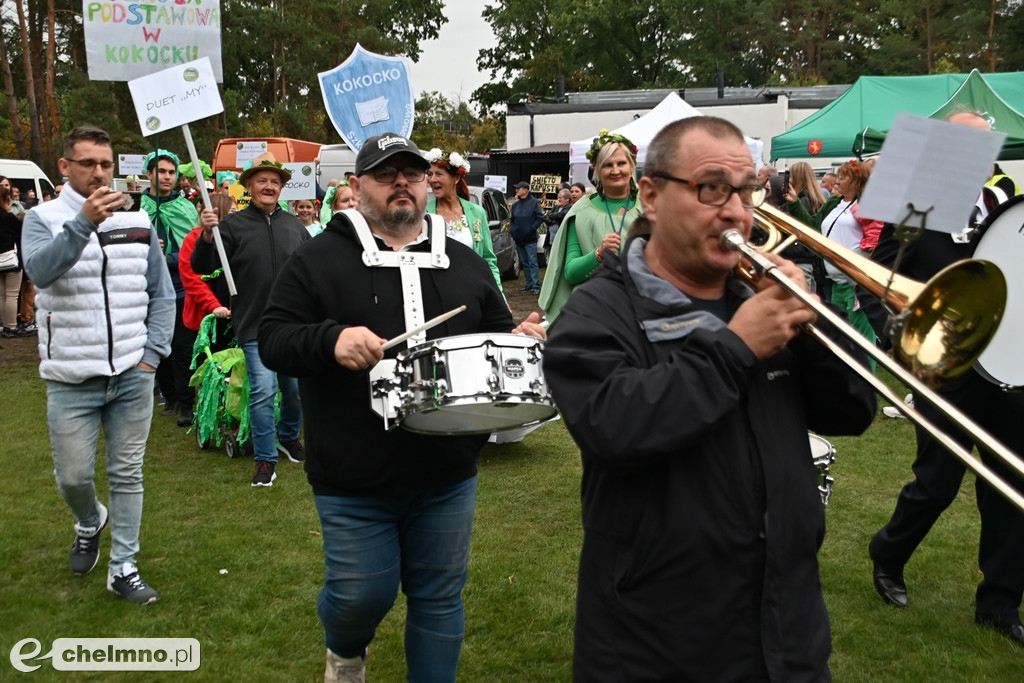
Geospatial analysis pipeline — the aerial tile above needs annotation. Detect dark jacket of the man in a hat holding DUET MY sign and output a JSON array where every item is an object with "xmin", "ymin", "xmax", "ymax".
[{"xmin": 191, "ymin": 204, "xmax": 310, "ymax": 345}]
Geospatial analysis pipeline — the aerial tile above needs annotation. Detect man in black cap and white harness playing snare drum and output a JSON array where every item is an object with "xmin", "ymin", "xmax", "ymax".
[{"xmin": 259, "ymin": 133, "xmax": 545, "ymax": 681}]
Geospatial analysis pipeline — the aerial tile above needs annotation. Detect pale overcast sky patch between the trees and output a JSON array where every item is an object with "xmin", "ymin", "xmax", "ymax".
[{"xmin": 412, "ymin": 0, "xmax": 497, "ymax": 101}]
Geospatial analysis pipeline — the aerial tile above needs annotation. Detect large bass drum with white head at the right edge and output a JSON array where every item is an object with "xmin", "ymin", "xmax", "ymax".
[{"xmin": 974, "ymin": 195, "xmax": 1024, "ymax": 391}]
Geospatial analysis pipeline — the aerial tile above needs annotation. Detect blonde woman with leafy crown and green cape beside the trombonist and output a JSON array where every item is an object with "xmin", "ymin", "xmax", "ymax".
[{"xmin": 540, "ymin": 130, "xmax": 642, "ymax": 325}]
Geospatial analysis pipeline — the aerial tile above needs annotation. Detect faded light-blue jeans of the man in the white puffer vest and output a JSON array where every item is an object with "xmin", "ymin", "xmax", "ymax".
[{"xmin": 46, "ymin": 368, "xmax": 156, "ymax": 573}]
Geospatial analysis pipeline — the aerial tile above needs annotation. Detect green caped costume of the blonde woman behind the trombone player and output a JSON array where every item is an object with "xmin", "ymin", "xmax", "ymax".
[{"xmin": 539, "ymin": 195, "xmax": 642, "ymax": 326}]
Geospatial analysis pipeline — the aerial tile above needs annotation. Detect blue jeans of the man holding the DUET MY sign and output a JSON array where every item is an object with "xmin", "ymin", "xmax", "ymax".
[{"xmin": 242, "ymin": 339, "xmax": 302, "ymax": 463}]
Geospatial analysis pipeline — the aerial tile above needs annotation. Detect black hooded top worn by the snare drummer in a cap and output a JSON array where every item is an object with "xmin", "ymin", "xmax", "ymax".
[{"xmin": 259, "ymin": 213, "xmax": 513, "ymax": 496}]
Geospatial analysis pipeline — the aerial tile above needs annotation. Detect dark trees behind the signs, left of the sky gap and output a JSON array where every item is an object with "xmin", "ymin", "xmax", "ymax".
[{"xmin": 0, "ymin": 0, "xmax": 445, "ymax": 169}]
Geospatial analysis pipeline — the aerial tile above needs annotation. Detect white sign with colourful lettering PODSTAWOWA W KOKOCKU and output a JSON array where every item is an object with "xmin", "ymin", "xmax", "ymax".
[{"xmin": 82, "ymin": 0, "xmax": 224, "ymax": 83}]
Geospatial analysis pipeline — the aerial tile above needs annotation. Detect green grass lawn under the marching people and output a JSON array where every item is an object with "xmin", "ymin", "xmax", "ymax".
[{"xmin": 0, "ymin": 333, "xmax": 1024, "ymax": 682}]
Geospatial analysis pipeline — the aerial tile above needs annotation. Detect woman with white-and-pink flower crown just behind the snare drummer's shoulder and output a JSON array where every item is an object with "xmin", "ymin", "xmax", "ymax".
[{"xmin": 424, "ymin": 147, "xmax": 505, "ymax": 294}]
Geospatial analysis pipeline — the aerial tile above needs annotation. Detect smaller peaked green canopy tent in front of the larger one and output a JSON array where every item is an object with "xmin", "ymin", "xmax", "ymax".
[{"xmin": 853, "ymin": 70, "xmax": 1024, "ymax": 160}]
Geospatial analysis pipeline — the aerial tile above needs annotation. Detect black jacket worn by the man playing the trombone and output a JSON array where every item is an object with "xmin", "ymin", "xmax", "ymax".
[{"xmin": 544, "ymin": 240, "xmax": 876, "ymax": 681}]
